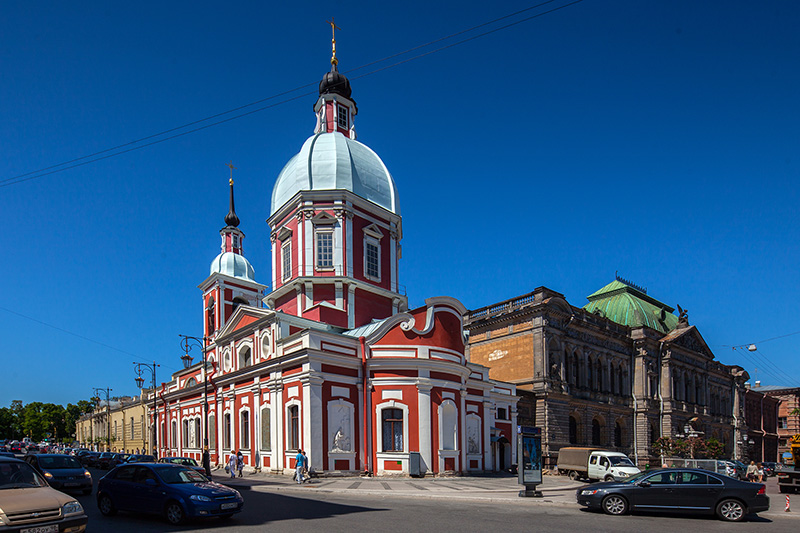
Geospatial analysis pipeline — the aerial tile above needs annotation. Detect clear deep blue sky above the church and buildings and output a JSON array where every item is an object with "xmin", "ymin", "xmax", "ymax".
[{"xmin": 0, "ymin": 0, "xmax": 800, "ymax": 406}]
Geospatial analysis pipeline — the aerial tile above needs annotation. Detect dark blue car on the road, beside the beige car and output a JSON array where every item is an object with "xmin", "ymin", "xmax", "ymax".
[{"xmin": 97, "ymin": 463, "xmax": 244, "ymax": 524}]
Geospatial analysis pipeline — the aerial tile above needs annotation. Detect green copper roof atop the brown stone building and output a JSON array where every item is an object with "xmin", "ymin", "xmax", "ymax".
[{"xmin": 583, "ymin": 279, "xmax": 678, "ymax": 333}]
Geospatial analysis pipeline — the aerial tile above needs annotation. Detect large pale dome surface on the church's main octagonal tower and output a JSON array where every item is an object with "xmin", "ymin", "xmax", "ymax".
[{"xmin": 272, "ymin": 132, "xmax": 400, "ymax": 215}]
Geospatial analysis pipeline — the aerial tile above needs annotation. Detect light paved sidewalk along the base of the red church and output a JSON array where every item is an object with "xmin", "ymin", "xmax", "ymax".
[{"xmin": 212, "ymin": 469, "xmax": 585, "ymax": 506}]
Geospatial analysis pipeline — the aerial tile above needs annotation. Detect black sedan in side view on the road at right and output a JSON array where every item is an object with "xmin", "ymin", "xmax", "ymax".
[{"xmin": 577, "ymin": 468, "xmax": 769, "ymax": 522}]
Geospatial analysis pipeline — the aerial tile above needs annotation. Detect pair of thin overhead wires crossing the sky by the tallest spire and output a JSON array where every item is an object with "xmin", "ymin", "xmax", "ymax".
[{"xmin": 0, "ymin": 0, "xmax": 584, "ymax": 187}]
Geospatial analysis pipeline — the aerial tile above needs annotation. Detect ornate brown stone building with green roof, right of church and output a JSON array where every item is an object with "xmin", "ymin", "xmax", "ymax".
[{"xmin": 465, "ymin": 278, "xmax": 748, "ymax": 466}]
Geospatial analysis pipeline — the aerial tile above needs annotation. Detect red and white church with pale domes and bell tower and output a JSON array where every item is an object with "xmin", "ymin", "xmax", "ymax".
[{"xmin": 152, "ymin": 61, "xmax": 518, "ymax": 475}]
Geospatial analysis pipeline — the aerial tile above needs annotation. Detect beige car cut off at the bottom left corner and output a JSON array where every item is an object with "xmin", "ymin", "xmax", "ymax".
[{"xmin": 0, "ymin": 457, "xmax": 89, "ymax": 533}]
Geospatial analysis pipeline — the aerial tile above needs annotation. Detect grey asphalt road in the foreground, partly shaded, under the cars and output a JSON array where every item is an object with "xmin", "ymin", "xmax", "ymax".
[{"xmin": 77, "ymin": 470, "xmax": 800, "ymax": 533}]
